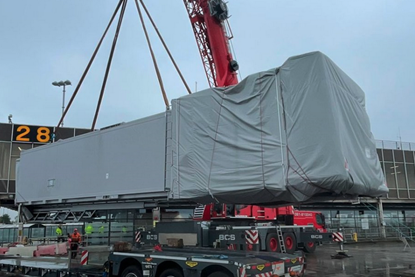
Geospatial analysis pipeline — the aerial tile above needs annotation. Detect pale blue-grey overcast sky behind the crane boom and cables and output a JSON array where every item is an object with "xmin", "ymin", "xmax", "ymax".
[{"xmin": 0, "ymin": 0, "xmax": 415, "ymax": 142}]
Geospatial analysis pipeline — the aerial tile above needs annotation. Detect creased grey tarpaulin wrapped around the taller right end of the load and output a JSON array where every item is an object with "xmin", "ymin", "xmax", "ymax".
[{"xmin": 172, "ymin": 52, "xmax": 388, "ymax": 204}]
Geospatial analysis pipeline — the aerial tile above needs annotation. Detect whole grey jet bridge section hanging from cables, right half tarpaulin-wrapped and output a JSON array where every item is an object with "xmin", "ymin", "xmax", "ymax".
[{"xmin": 16, "ymin": 52, "xmax": 388, "ymax": 222}]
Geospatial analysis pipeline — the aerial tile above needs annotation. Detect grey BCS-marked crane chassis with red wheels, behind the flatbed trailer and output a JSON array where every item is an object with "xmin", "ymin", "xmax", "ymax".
[{"xmin": 153, "ymin": 218, "xmax": 334, "ymax": 254}]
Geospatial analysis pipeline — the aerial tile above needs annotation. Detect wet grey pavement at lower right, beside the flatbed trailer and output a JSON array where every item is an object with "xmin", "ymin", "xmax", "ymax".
[{"xmin": 305, "ymin": 242, "xmax": 415, "ymax": 277}]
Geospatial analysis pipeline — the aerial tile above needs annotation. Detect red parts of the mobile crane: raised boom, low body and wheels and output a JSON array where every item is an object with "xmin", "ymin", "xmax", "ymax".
[{"xmin": 183, "ymin": 0, "xmax": 326, "ymax": 252}]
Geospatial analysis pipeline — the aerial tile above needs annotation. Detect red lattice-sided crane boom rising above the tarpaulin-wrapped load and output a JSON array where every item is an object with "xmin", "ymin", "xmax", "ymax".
[{"xmin": 183, "ymin": 0, "xmax": 238, "ymax": 87}]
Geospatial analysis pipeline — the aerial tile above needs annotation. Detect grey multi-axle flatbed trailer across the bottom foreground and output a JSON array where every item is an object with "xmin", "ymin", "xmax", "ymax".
[{"xmin": 0, "ymin": 231, "xmax": 305, "ymax": 277}]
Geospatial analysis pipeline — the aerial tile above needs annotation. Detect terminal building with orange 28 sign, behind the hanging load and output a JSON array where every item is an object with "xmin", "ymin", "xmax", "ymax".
[{"xmin": 0, "ymin": 123, "xmax": 415, "ymax": 242}]
